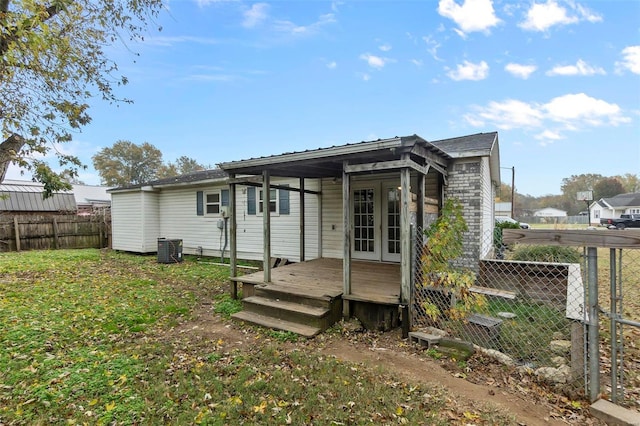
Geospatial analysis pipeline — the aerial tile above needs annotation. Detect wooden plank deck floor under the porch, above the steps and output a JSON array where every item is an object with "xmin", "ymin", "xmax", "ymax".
[{"xmin": 232, "ymin": 258, "xmax": 400, "ymax": 305}]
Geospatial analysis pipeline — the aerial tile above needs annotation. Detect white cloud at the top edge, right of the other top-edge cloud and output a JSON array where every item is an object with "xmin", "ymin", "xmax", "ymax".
[{"xmin": 518, "ymin": 0, "xmax": 602, "ymax": 32}]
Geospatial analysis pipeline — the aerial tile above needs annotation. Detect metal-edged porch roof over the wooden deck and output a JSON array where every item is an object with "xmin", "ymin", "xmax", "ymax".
[{"xmin": 220, "ymin": 135, "xmax": 451, "ymax": 178}]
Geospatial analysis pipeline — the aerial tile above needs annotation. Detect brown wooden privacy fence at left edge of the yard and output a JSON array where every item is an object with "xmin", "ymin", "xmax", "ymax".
[{"xmin": 0, "ymin": 211, "xmax": 111, "ymax": 252}]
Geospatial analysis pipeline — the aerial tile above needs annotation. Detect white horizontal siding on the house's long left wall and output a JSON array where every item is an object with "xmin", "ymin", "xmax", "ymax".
[{"xmin": 113, "ymin": 179, "xmax": 320, "ymax": 261}]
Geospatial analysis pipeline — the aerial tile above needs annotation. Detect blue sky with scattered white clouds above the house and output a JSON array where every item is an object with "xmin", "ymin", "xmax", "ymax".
[{"xmin": 7, "ymin": 0, "xmax": 640, "ymax": 197}]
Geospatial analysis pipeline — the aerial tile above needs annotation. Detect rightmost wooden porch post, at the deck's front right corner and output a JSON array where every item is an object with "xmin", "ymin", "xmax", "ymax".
[{"xmin": 400, "ymin": 163, "xmax": 411, "ymax": 306}]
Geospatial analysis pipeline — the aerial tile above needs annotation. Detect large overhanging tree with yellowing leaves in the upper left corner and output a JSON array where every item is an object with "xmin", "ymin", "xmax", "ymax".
[{"xmin": 0, "ymin": 0, "xmax": 163, "ymax": 194}]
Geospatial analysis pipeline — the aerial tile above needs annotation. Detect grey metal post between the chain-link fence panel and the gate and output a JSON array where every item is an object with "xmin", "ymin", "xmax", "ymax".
[{"xmin": 587, "ymin": 247, "xmax": 600, "ymax": 402}]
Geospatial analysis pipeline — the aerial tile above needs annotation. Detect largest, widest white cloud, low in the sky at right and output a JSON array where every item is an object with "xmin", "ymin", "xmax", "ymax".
[{"xmin": 464, "ymin": 93, "xmax": 631, "ymax": 136}]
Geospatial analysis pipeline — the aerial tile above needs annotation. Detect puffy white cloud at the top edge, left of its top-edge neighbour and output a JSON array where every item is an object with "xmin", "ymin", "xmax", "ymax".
[{"xmin": 438, "ymin": 0, "xmax": 501, "ymax": 37}]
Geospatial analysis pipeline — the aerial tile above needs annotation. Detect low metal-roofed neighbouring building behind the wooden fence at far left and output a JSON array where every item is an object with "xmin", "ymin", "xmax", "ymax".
[{"xmin": 0, "ymin": 179, "xmax": 77, "ymax": 215}]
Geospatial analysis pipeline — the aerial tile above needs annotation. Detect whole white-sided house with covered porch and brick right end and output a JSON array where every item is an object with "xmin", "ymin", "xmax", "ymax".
[{"xmin": 109, "ymin": 132, "xmax": 500, "ymax": 335}]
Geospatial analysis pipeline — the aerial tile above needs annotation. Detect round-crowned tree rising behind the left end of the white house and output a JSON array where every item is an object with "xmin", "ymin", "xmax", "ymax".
[{"xmin": 92, "ymin": 141, "xmax": 163, "ymax": 186}]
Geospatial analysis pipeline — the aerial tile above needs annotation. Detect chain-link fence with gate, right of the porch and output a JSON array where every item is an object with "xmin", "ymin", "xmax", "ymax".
[{"xmin": 411, "ymin": 228, "xmax": 640, "ymax": 409}]
